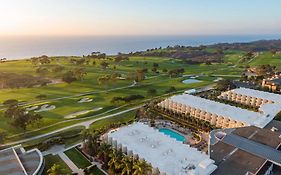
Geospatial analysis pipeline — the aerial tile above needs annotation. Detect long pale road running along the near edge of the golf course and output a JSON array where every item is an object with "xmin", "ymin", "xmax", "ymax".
[{"xmin": 0, "ymin": 106, "xmax": 141, "ymax": 146}]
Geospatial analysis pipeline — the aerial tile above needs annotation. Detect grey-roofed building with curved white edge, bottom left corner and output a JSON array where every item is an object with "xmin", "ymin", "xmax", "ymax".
[{"xmin": 0, "ymin": 145, "xmax": 44, "ymax": 175}]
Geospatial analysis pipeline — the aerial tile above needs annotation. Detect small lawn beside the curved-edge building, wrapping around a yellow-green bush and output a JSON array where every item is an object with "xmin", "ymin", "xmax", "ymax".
[{"xmin": 43, "ymin": 155, "xmax": 72, "ymax": 175}]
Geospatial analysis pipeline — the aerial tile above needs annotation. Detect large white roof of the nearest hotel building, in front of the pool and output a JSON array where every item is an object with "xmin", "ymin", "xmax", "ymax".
[{"xmin": 108, "ymin": 123, "xmax": 216, "ymax": 175}]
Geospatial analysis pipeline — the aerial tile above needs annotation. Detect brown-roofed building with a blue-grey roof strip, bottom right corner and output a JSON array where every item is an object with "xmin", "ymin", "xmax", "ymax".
[{"xmin": 209, "ymin": 126, "xmax": 281, "ymax": 175}]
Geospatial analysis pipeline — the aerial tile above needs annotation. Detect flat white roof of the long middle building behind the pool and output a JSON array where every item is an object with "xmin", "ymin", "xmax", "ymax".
[{"xmin": 170, "ymin": 94, "xmax": 272, "ymax": 128}]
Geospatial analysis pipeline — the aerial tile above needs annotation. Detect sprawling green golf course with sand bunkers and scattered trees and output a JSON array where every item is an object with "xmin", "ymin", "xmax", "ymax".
[{"xmin": 0, "ymin": 48, "xmax": 281, "ymax": 143}]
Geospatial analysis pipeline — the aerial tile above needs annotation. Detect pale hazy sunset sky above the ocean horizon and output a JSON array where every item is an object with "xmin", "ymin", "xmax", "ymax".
[{"xmin": 0, "ymin": 0, "xmax": 281, "ymax": 36}]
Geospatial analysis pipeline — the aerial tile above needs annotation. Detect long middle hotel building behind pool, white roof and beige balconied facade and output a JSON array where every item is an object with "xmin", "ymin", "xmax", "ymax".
[{"xmin": 158, "ymin": 94, "xmax": 273, "ymax": 128}]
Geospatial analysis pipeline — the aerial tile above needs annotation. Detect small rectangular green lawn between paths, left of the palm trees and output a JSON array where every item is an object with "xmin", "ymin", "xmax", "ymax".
[{"xmin": 64, "ymin": 148, "xmax": 91, "ymax": 169}]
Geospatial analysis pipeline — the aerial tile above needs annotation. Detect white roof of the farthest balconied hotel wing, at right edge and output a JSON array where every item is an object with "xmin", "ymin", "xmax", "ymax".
[{"xmin": 231, "ymin": 88, "xmax": 281, "ymax": 104}]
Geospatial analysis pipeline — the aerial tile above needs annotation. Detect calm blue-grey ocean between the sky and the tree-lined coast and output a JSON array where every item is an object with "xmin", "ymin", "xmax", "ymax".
[{"xmin": 0, "ymin": 35, "xmax": 281, "ymax": 59}]
